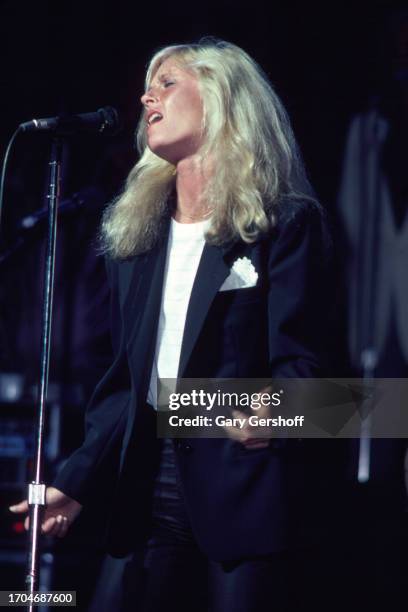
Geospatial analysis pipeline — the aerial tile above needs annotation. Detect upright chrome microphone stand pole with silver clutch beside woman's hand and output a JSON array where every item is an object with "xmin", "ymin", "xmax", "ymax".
[{"xmin": 25, "ymin": 136, "xmax": 62, "ymax": 612}]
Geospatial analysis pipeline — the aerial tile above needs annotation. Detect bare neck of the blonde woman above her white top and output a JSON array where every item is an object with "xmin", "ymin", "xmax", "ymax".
[{"xmin": 174, "ymin": 155, "xmax": 212, "ymax": 223}]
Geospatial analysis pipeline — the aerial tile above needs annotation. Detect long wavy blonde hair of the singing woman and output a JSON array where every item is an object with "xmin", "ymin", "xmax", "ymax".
[{"xmin": 101, "ymin": 38, "xmax": 312, "ymax": 259}]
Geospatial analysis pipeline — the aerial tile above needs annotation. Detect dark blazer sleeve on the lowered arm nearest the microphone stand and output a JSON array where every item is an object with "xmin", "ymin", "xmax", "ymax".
[{"xmin": 53, "ymin": 261, "xmax": 131, "ymax": 504}]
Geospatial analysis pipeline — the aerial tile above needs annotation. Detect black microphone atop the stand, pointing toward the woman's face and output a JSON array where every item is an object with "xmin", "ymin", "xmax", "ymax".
[{"xmin": 19, "ymin": 106, "xmax": 121, "ymax": 136}]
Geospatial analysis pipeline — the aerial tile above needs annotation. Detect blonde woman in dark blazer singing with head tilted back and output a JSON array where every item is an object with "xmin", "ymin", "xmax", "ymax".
[{"xmin": 13, "ymin": 39, "xmax": 342, "ymax": 612}]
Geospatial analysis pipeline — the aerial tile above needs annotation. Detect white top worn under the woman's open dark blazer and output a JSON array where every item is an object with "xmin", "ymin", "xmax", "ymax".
[{"xmin": 147, "ymin": 219, "xmax": 210, "ymax": 409}]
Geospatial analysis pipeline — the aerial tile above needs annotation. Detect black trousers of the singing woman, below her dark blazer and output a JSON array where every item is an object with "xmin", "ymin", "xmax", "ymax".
[{"xmin": 118, "ymin": 440, "xmax": 296, "ymax": 612}]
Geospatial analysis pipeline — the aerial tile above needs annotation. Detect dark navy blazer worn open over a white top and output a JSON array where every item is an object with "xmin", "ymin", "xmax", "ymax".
[{"xmin": 54, "ymin": 200, "xmax": 342, "ymax": 560}]
